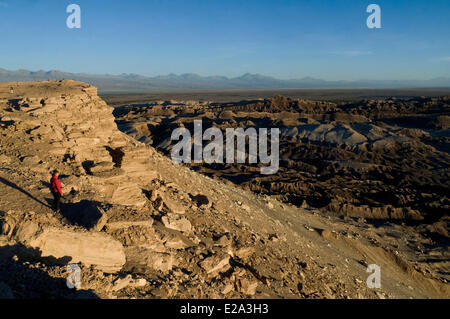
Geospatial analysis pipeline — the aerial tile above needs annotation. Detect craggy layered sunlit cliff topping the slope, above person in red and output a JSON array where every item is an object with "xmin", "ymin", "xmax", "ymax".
[{"xmin": 1, "ymin": 81, "xmax": 157, "ymax": 206}]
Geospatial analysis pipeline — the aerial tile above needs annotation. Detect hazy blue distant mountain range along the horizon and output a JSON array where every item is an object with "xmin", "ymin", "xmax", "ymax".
[{"xmin": 0, "ymin": 68, "xmax": 450, "ymax": 92}]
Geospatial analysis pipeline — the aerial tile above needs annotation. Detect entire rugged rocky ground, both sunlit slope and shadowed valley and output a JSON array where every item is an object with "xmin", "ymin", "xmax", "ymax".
[{"xmin": 0, "ymin": 81, "xmax": 450, "ymax": 298}]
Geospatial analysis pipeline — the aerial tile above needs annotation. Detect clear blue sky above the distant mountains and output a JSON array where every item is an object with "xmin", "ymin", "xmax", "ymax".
[{"xmin": 0, "ymin": 0, "xmax": 450, "ymax": 80}]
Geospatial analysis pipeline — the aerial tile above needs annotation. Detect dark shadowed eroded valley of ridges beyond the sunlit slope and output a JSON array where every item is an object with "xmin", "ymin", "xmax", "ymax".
[{"xmin": 115, "ymin": 96, "xmax": 450, "ymax": 223}]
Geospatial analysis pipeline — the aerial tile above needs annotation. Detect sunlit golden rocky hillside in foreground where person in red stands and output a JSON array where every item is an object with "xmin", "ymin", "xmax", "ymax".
[{"xmin": 0, "ymin": 81, "xmax": 449, "ymax": 298}]
